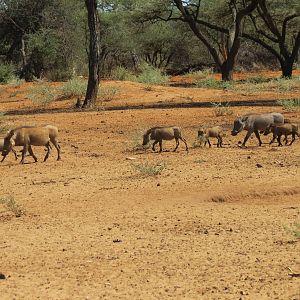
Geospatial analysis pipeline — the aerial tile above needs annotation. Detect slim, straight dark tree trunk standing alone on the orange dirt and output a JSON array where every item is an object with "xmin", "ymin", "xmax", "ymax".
[{"xmin": 83, "ymin": 0, "xmax": 100, "ymax": 107}]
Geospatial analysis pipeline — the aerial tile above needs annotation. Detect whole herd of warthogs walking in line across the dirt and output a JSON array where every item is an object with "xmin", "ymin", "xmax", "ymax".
[{"xmin": 0, "ymin": 113, "xmax": 299, "ymax": 163}]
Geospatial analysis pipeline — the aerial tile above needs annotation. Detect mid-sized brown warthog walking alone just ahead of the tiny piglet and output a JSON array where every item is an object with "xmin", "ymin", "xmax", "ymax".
[{"xmin": 143, "ymin": 126, "xmax": 189, "ymax": 152}]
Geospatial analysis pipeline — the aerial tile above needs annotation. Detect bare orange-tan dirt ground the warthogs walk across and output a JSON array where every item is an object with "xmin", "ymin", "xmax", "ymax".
[{"xmin": 0, "ymin": 71, "xmax": 300, "ymax": 300}]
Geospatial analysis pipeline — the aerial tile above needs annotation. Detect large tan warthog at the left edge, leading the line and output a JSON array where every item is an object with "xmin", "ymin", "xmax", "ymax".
[{"xmin": 2, "ymin": 125, "xmax": 60, "ymax": 164}]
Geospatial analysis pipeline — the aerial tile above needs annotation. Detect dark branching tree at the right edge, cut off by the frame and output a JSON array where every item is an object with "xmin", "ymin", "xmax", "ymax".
[{"xmin": 242, "ymin": 0, "xmax": 300, "ymax": 77}]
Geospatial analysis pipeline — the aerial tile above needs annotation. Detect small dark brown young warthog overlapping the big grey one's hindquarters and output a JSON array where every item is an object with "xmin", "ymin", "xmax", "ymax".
[{"xmin": 264, "ymin": 123, "xmax": 299, "ymax": 146}]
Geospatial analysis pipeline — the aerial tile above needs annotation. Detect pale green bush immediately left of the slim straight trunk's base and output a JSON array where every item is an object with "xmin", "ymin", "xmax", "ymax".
[{"xmin": 59, "ymin": 77, "xmax": 87, "ymax": 98}]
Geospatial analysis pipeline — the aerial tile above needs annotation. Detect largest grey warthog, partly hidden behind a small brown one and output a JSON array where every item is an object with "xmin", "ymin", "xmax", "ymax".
[{"xmin": 231, "ymin": 113, "xmax": 284, "ymax": 147}]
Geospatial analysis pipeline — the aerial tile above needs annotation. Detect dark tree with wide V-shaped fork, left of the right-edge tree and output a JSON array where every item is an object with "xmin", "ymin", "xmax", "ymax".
[{"xmin": 168, "ymin": 0, "xmax": 259, "ymax": 81}]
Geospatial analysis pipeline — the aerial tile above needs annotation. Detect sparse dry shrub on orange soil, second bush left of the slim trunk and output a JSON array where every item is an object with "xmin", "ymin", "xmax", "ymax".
[{"xmin": 27, "ymin": 83, "xmax": 57, "ymax": 106}]
